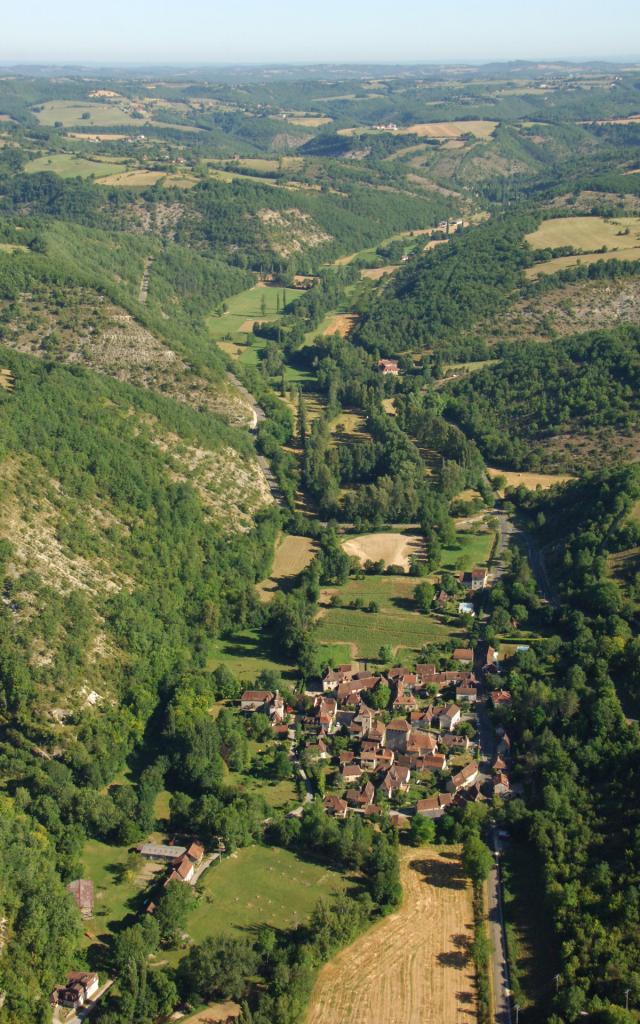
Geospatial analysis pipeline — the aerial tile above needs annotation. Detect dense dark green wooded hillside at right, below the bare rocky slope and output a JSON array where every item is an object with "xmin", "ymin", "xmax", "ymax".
[{"xmin": 446, "ymin": 327, "xmax": 640, "ymax": 470}]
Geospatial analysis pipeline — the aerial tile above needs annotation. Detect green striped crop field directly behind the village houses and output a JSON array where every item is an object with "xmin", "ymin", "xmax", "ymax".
[{"xmin": 316, "ymin": 577, "xmax": 461, "ymax": 660}]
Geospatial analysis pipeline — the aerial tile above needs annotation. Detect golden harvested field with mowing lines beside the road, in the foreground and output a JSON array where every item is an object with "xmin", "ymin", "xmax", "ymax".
[{"xmin": 306, "ymin": 847, "xmax": 476, "ymax": 1024}]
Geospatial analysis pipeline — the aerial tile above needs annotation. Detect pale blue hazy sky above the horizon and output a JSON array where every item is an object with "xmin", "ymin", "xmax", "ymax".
[{"xmin": 0, "ymin": 0, "xmax": 640, "ymax": 65}]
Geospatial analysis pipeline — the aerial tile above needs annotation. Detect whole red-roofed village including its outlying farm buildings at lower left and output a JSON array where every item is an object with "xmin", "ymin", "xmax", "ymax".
[{"xmin": 51, "ymin": 567, "xmax": 522, "ymax": 1024}]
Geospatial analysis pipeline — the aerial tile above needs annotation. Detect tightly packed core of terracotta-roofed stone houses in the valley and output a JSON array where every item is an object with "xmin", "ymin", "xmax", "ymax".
[{"xmin": 241, "ymin": 634, "xmax": 511, "ymax": 818}]
